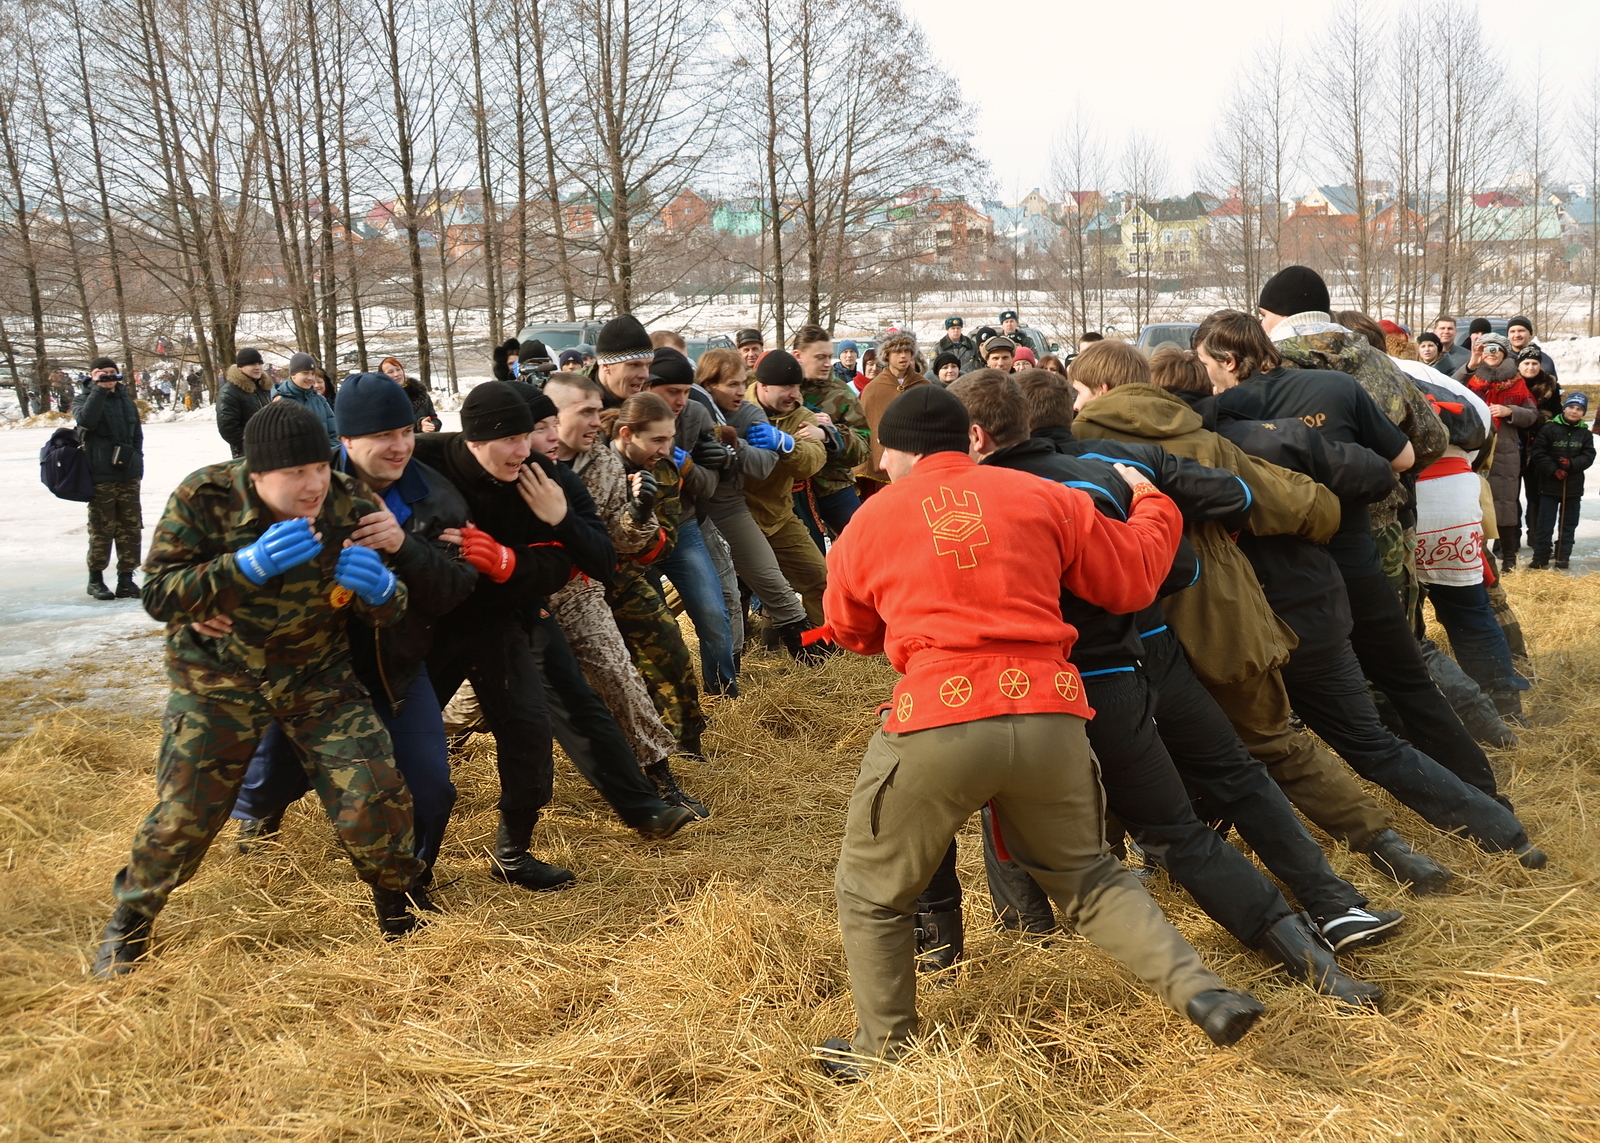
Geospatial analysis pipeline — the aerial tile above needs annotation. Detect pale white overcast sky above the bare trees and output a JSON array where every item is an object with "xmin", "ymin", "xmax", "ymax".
[{"xmin": 908, "ymin": 0, "xmax": 1600, "ymax": 202}]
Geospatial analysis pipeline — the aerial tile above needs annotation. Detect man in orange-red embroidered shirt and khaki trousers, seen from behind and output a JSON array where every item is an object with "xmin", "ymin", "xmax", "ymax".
[{"xmin": 821, "ymin": 386, "xmax": 1262, "ymax": 1079}]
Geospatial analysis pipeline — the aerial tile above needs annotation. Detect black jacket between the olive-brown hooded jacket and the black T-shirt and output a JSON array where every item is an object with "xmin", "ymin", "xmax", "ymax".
[{"xmin": 1214, "ymin": 400, "xmax": 1395, "ymax": 650}]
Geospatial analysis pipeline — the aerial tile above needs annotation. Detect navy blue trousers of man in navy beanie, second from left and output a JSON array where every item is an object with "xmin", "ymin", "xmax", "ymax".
[{"xmin": 234, "ymin": 666, "xmax": 456, "ymax": 877}]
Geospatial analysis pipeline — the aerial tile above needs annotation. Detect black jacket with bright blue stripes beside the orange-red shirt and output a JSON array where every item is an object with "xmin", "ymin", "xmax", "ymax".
[{"xmin": 984, "ymin": 429, "xmax": 1250, "ymax": 674}]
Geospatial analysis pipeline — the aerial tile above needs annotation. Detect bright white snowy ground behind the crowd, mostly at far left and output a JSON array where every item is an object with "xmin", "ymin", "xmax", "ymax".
[{"xmin": 0, "ymin": 410, "xmax": 1600, "ymax": 676}]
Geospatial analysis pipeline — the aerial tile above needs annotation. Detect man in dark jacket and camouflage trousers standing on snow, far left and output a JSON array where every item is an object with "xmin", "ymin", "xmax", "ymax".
[{"xmin": 72, "ymin": 357, "xmax": 144, "ymax": 599}]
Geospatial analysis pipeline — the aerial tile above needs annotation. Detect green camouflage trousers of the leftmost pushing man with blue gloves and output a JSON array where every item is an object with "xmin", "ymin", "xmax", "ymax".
[{"xmin": 115, "ymin": 676, "xmax": 422, "ymax": 917}]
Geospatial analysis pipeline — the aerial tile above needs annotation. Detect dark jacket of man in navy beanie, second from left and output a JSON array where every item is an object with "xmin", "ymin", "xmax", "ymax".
[{"xmin": 334, "ymin": 450, "xmax": 478, "ymax": 716}]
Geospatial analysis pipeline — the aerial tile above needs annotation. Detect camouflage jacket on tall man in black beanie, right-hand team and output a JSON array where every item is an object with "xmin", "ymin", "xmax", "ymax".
[{"xmin": 1272, "ymin": 314, "xmax": 1450, "ymax": 528}]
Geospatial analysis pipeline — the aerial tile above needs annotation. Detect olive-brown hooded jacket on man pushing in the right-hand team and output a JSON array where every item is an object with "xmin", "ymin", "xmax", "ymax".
[{"xmin": 1072, "ymin": 384, "xmax": 1339, "ymax": 685}]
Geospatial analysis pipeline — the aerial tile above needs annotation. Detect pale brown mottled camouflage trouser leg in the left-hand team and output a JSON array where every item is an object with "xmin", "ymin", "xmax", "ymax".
[{"xmin": 550, "ymin": 580, "xmax": 682, "ymax": 765}]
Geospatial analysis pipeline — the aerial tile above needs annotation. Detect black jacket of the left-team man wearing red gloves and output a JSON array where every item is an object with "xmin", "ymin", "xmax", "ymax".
[{"xmin": 416, "ymin": 432, "xmax": 616, "ymax": 628}]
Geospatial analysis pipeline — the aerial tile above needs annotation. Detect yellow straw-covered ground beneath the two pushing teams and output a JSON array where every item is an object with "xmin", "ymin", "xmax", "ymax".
[{"xmin": 0, "ymin": 573, "xmax": 1600, "ymax": 1143}]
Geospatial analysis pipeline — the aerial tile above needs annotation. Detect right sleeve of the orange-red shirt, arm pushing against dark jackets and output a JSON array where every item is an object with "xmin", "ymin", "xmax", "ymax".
[{"xmin": 1058, "ymin": 485, "xmax": 1184, "ymax": 615}]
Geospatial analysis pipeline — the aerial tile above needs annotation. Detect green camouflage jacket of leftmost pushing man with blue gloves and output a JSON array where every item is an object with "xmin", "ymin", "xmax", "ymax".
[{"xmin": 141, "ymin": 459, "xmax": 406, "ymax": 693}]
